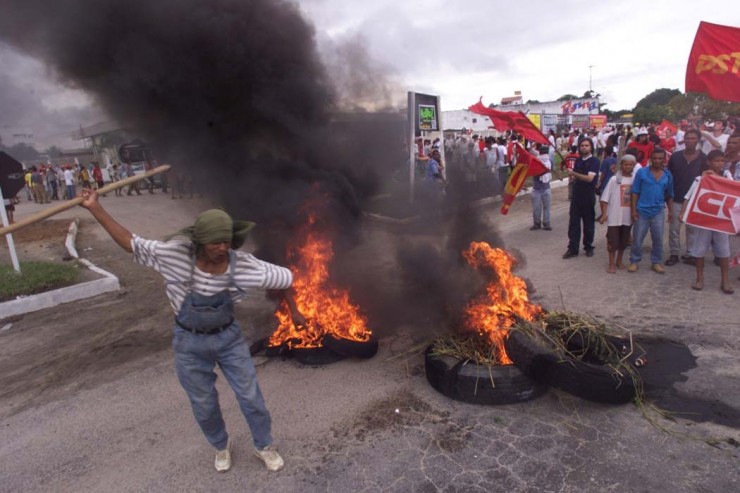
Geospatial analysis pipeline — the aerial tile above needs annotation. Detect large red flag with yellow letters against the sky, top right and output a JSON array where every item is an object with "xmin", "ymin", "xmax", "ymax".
[{"xmin": 686, "ymin": 22, "xmax": 740, "ymax": 102}]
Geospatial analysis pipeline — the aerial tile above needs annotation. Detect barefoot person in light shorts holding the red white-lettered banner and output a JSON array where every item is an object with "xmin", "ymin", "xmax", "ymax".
[{"xmin": 679, "ymin": 149, "xmax": 735, "ymax": 294}]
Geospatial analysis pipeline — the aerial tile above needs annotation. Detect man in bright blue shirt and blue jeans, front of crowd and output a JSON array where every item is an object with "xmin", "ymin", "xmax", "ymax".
[{"xmin": 627, "ymin": 147, "xmax": 673, "ymax": 274}]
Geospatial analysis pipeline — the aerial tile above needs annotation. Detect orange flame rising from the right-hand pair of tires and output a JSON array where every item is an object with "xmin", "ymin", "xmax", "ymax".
[{"xmin": 463, "ymin": 242, "xmax": 542, "ymax": 365}]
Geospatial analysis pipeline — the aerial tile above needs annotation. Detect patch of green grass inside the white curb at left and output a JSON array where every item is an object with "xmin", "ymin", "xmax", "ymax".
[{"xmin": 0, "ymin": 262, "xmax": 80, "ymax": 302}]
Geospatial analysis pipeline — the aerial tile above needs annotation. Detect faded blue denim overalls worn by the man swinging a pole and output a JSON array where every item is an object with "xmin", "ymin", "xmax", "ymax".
[{"xmin": 170, "ymin": 250, "xmax": 272, "ymax": 450}]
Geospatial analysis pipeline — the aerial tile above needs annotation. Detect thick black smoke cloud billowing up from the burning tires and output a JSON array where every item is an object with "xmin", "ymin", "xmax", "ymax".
[{"xmin": 0, "ymin": 0, "xmax": 508, "ymax": 336}]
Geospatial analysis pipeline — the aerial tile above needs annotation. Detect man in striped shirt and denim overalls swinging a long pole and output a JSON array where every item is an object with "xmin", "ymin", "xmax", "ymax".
[{"xmin": 81, "ymin": 189, "xmax": 305, "ymax": 472}]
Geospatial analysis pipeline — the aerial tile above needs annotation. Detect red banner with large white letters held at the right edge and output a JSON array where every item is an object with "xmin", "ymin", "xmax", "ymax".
[{"xmin": 683, "ymin": 175, "xmax": 740, "ymax": 235}]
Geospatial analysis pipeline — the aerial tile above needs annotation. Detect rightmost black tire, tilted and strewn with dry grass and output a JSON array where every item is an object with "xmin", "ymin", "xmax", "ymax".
[{"xmin": 505, "ymin": 330, "xmax": 635, "ymax": 404}]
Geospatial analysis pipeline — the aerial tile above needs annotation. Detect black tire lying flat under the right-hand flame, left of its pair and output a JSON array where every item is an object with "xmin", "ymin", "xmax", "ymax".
[{"xmin": 424, "ymin": 345, "xmax": 547, "ymax": 405}]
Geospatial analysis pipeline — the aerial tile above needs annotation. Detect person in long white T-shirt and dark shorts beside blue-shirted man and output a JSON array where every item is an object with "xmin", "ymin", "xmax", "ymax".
[{"xmin": 599, "ymin": 154, "xmax": 637, "ymax": 274}]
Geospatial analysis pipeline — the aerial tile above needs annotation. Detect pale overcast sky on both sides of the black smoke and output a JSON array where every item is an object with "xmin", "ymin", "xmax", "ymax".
[{"xmin": 0, "ymin": 0, "xmax": 740, "ymax": 146}]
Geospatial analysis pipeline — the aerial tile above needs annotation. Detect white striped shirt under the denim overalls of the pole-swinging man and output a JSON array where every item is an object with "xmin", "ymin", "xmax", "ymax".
[{"xmin": 131, "ymin": 235, "xmax": 293, "ymax": 315}]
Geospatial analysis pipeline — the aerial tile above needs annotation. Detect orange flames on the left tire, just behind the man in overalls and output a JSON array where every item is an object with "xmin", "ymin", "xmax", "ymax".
[{"xmin": 267, "ymin": 216, "xmax": 372, "ymax": 348}]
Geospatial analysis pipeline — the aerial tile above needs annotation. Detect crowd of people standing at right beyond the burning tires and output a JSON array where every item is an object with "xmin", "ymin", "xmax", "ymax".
[{"xmin": 416, "ymin": 120, "xmax": 740, "ymax": 294}]
